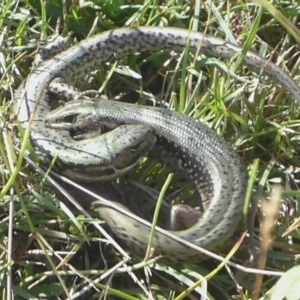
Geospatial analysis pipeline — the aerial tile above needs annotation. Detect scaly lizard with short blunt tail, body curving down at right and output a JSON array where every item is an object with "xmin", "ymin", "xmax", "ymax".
[{"xmin": 45, "ymin": 99, "xmax": 247, "ymax": 261}]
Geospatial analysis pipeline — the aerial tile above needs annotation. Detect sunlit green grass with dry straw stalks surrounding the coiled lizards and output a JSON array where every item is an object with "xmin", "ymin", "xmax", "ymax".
[{"xmin": 0, "ymin": 0, "xmax": 300, "ymax": 299}]
